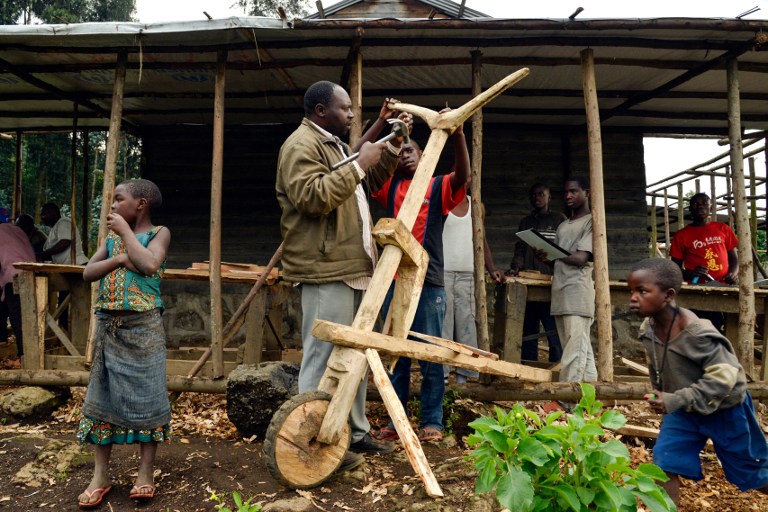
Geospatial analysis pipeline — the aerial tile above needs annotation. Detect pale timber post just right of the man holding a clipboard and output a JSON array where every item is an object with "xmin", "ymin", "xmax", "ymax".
[{"xmin": 581, "ymin": 49, "xmax": 613, "ymax": 381}]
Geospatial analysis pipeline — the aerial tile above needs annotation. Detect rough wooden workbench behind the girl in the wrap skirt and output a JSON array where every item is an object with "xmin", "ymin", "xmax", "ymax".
[{"xmin": 14, "ymin": 263, "xmax": 282, "ymax": 377}]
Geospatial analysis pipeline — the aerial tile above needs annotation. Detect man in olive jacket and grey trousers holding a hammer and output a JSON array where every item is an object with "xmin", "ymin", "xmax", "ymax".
[{"xmin": 275, "ymin": 81, "xmax": 401, "ymax": 458}]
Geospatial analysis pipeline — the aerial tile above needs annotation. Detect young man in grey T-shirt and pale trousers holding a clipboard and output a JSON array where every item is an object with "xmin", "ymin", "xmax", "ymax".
[{"xmin": 535, "ymin": 176, "xmax": 597, "ymax": 396}]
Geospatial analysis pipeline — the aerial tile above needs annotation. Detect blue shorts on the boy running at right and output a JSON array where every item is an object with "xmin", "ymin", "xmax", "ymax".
[{"xmin": 653, "ymin": 393, "xmax": 768, "ymax": 491}]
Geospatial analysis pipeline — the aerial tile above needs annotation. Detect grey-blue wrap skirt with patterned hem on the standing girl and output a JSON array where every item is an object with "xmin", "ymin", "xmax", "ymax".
[{"xmin": 78, "ymin": 309, "xmax": 171, "ymax": 436}]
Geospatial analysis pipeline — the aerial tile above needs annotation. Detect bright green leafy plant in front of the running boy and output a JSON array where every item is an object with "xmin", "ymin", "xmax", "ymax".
[{"xmin": 467, "ymin": 384, "xmax": 675, "ymax": 512}]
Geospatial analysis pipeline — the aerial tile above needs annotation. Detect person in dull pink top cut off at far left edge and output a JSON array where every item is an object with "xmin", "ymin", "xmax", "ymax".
[{"xmin": 0, "ymin": 210, "xmax": 35, "ymax": 366}]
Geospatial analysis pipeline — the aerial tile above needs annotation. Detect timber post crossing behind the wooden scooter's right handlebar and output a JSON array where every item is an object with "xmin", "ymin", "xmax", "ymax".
[{"xmin": 469, "ymin": 50, "xmax": 490, "ymax": 351}]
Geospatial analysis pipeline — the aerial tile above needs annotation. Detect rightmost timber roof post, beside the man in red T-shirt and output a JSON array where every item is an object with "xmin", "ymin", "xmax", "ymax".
[{"xmin": 726, "ymin": 59, "xmax": 755, "ymax": 377}]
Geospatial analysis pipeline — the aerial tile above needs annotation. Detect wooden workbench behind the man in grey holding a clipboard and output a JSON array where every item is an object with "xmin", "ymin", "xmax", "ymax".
[{"xmin": 493, "ymin": 277, "xmax": 768, "ymax": 370}]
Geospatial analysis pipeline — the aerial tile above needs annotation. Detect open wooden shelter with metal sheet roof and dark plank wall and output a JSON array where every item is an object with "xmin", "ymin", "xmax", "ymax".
[{"xmin": 0, "ymin": 0, "xmax": 768, "ymax": 386}]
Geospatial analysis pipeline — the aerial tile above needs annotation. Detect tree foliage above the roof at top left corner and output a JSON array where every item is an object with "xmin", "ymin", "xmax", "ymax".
[{"xmin": 0, "ymin": 0, "xmax": 136, "ymax": 25}]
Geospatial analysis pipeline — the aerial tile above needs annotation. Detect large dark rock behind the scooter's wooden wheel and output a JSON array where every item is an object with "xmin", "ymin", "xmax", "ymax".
[{"xmin": 227, "ymin": 362, "xmax": 299, "ymax": 439}]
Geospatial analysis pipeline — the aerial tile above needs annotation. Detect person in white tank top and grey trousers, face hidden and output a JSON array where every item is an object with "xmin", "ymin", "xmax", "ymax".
[{"xmin": 442, "ymin": 180, "xmax": 504, "ymax": 384}]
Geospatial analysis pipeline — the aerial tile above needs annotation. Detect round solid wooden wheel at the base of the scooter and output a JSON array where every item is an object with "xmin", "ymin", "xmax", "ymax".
[{"xmin": 264, "ymin": 391, "xmax": 351, "ymax": 489}]
